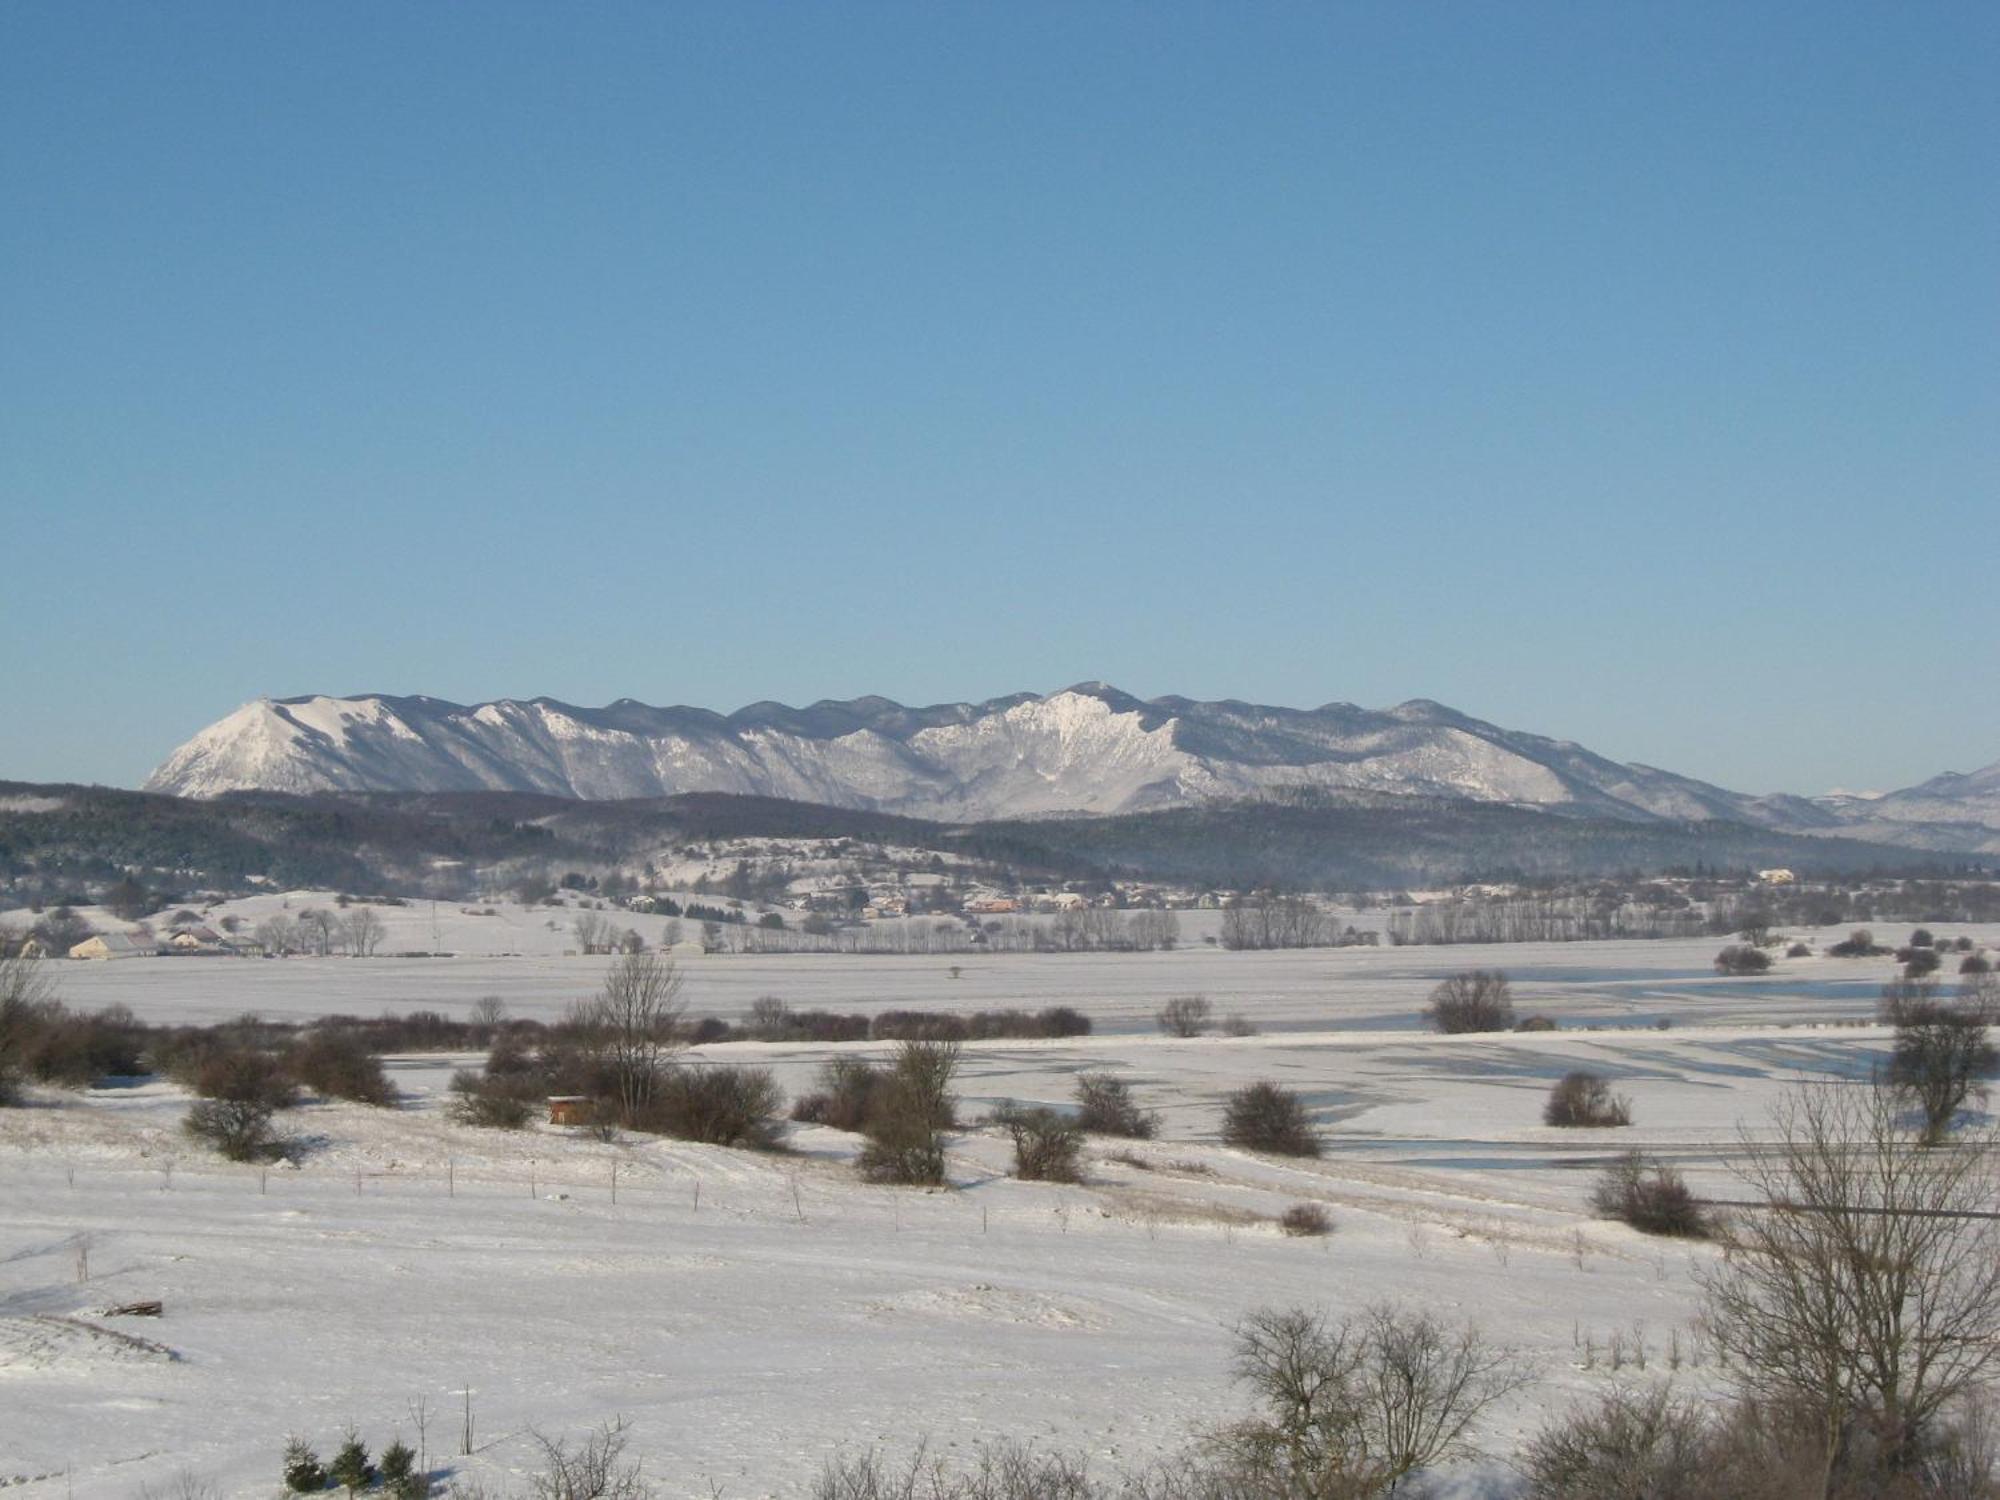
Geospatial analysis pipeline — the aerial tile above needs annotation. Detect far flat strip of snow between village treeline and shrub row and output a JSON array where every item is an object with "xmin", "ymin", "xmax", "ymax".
[{"xmin": 31, "ymin": 908, "xmax": 2000, "ymax": 1032}]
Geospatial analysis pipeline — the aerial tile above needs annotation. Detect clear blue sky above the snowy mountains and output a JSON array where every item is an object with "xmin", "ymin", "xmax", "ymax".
[{"xmin": 0, "ymin": 0, "xmax": 2000, "ymax": 792}]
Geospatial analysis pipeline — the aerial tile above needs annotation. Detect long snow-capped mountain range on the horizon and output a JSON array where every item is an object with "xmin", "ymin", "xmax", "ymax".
[{"xmin": 146, "ymin": 682, "xmax": 2000, "ymax": 852}]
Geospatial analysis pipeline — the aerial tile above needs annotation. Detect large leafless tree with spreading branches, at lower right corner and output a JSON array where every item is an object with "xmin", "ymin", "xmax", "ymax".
[{"xmin": 1702, "ymin": 1082, "xmax": 2000, "ymax": 1494}]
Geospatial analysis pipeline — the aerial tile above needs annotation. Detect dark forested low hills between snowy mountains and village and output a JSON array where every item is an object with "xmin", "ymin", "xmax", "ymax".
[{"xmin": 0, "ymin": 784, "xmax": 1964, "ymax": 898}]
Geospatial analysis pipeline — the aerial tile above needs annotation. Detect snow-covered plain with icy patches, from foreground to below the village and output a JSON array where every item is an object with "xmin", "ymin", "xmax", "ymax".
[{"xmin": 0, "ymin": 936, "xmax": 1996, "ymax": 1498}]
